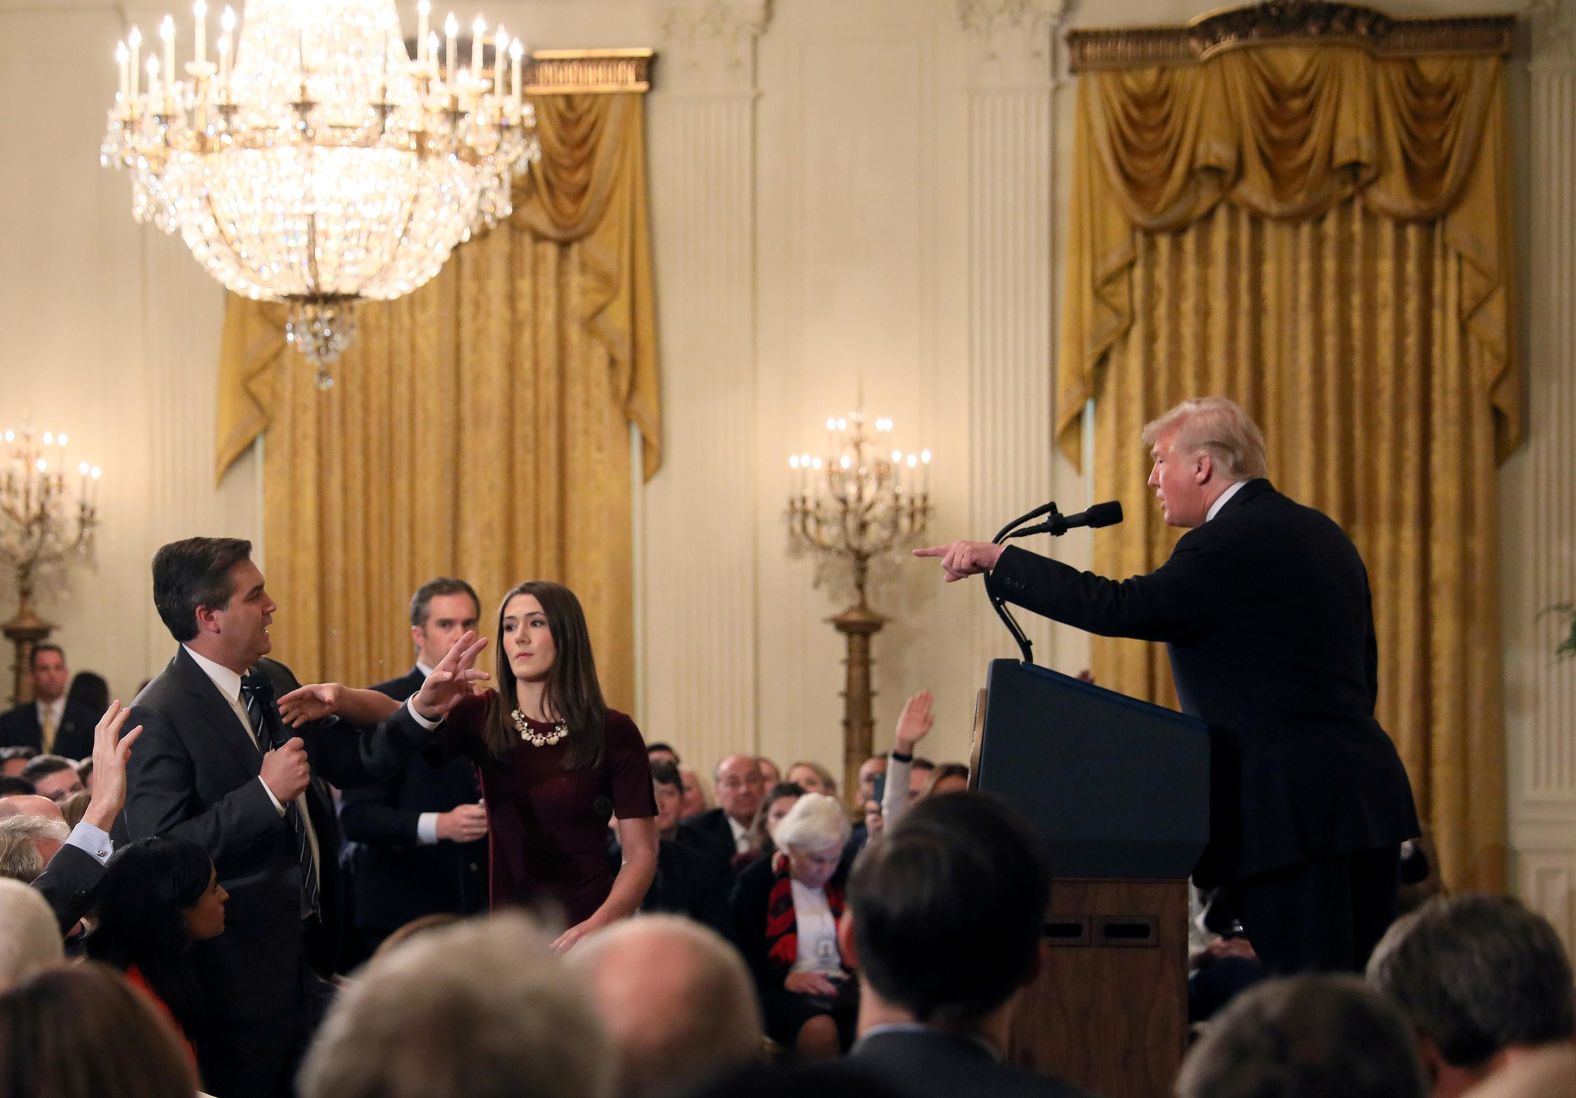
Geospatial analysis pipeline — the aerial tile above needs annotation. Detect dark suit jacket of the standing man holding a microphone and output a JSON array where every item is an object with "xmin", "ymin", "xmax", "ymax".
[{"xmin": 123, "ymin": 647, "xmax": 427, "ymax": 1021}]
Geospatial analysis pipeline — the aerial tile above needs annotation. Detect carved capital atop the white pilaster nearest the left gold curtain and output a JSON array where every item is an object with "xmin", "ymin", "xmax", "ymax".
[{"xmin": 657, "ymin": 0, "xmax": 771, "ymax": 95}]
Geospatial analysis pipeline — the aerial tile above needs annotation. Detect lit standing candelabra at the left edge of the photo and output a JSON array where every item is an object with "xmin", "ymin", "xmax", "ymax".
[{"xmin": 0, "ymin": 428, "xmax": 101, "ymax": 704}]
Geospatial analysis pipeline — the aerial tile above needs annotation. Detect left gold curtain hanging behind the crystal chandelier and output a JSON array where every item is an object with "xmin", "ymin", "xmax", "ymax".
[{"xmin": 208, "ymin": 93, "xmax": 662, "ymax": 709}]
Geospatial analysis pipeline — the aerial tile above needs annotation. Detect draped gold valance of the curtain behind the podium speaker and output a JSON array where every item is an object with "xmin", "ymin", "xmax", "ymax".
[{"xmin": 1057, "ymin": 37, "xmax": 1521, "ymax": 462}]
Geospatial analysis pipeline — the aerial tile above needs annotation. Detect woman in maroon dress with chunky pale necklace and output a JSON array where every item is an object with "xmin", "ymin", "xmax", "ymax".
[{"xmin": 441, "ymin": 580, "xmax": 657, "ymax": 950}]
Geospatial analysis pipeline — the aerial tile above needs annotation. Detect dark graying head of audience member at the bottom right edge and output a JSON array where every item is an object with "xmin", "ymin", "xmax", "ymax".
[{"xmin": 1368, "ymin": 896, "xmax": 1576, "ymax": 1098}]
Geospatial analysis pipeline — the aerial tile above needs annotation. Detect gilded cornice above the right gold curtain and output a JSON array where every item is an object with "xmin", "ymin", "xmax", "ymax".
[{"xmin": 1067, "ymin": 0, "xmax": 1516, "ymax": 72}]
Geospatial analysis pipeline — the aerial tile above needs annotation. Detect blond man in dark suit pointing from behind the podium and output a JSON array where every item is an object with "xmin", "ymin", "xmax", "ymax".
[{"xmin": 914, "ymin": 397, "xmax": 1422, "ymax": 972}]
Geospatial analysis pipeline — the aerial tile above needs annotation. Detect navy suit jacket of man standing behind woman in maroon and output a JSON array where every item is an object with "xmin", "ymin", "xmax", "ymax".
[{"xmin": 339, "ymin": 668, "xmax": 487, "ymax": 931}]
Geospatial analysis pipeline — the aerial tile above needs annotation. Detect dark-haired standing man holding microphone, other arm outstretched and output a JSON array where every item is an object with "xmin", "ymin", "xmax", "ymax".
[{"xmin": 125, "ymin": 537, "xmax": 482, "ymax": 1098}]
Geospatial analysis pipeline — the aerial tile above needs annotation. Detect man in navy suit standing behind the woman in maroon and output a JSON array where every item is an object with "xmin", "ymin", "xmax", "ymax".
[{"xmin": 339, "ymin": 577, "xmax": 487, "ymax": 955}]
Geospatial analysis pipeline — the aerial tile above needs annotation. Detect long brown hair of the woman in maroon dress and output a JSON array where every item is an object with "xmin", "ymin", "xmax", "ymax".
[{"xmin": 487, "ymin": 580, "xmax": 607, "ymax": 770}]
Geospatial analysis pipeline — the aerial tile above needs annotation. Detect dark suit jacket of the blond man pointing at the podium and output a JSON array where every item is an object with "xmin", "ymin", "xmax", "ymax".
[{"xmin": 987, "ymin": 479, "xmax": 1418, "ymax": 884}]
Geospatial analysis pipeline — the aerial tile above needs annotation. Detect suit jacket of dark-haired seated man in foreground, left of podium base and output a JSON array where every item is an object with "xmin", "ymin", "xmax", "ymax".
[{"xmin": 848, "ymin": 1030, "xmax": 1089, "ymax": 1098}]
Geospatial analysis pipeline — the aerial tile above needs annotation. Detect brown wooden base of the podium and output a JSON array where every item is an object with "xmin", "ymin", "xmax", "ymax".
[{"xmin": 1009, "ymin": 877, "xmax": 1188, "ymax": 1098}]
